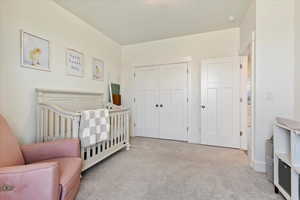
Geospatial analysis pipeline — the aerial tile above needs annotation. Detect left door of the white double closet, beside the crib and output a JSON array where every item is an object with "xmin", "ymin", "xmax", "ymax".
[{"xmin": 134, "ymin": 67, "xmax": 159, "ymax": 138}]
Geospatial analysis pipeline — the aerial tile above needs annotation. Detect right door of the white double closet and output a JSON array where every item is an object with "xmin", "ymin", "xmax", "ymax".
[{"xmin": 159, "ymin": 63, "xmax": 188, "ymax": 141}]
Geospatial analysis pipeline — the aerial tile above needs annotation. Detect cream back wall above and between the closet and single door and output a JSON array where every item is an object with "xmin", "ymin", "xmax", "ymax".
[{"xmin": 122, "ymin": 28, "xmax": 240, "ymax": 143}]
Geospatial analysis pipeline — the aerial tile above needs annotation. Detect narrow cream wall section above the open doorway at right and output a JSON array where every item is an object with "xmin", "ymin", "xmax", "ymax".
[{"xmin": 240, "ymin": 0, "xmax": 256, "ymax": 53}]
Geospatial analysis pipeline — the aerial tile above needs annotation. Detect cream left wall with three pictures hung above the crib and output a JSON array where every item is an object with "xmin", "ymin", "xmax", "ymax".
[{"xmin": 0, "ymin": 0, "xmax": 121, "ymax": 143}]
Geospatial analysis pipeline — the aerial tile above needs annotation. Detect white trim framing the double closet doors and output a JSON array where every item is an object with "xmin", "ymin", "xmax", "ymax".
[{"xmin": 131, "ymin": 57, "xmax": 193, "ymax": 143}]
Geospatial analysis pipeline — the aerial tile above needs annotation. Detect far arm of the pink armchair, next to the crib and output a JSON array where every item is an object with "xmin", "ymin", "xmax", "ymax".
[{"xmin": 21, "ymin": 139, "xmax": 80, "ymax": 163}]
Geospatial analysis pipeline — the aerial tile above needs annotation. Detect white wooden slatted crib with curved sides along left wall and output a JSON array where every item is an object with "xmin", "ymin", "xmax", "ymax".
[{"xmin": 36, "ymin": 89, "xmax": 130, "ymax": 171}]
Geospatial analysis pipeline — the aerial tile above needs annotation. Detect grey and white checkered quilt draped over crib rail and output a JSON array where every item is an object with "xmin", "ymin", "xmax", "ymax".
[{"xmin": 79, "ymin": 109, "xmax": 110, "ymax": 147}]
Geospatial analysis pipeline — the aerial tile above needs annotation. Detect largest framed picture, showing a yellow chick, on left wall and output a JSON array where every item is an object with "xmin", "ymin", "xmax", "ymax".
[{"xmin": 20, "ymin": 30, "xmax": 51, "ymax": 71}]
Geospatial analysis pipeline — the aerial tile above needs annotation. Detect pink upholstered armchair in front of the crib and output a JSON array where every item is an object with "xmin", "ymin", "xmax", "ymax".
[{"xmin": 0, "ymin": 115, "xmax": 82, "ymax": 200}]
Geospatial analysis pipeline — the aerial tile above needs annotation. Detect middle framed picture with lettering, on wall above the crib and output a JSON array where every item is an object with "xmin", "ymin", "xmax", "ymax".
[{"xmin": 66, "ymin": 49, "xmax": 84, "ymax": 77}]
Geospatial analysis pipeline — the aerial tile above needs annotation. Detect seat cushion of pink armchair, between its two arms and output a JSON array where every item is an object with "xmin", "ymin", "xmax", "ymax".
[{"xmin": 39, "ymin": 157, "xmax": 82, "ymax": 200}]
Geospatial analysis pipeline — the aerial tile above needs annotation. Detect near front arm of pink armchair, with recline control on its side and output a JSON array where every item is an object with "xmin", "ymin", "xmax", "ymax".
[{"xmin": 0, "ymin": 162, "xmax": 59, "ymax": 200}]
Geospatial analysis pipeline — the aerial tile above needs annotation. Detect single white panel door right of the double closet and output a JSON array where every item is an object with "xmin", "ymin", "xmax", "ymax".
[{"xmin": 201, "ymin": 57, "xmax": 240, "ymax": 148}]
